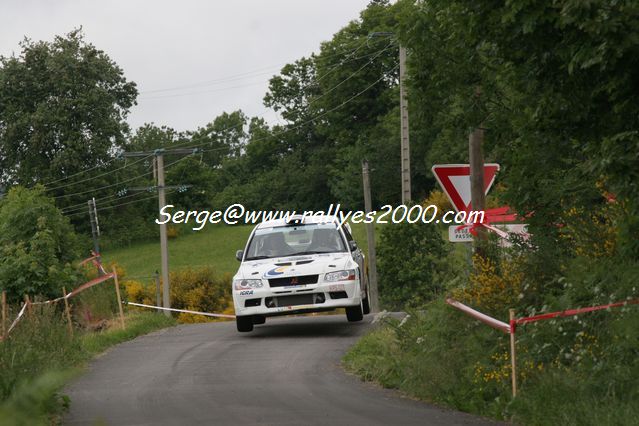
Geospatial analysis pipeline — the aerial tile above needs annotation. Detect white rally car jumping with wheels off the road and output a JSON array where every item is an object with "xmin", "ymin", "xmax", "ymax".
[{"xmin": 233, "ymin": 215, "xmax": 370, "ymax": 332}]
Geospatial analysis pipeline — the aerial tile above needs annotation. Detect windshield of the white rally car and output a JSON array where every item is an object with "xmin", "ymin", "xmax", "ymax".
[{"xmin": 246, "ymin": 223, "xmax": 347, "ymax": 260}]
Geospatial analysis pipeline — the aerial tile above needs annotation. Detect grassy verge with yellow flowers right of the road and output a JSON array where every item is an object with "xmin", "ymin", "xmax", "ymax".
[{"xmin": 343, "ymin": 301, "xmax": 639, "ymax": 425}]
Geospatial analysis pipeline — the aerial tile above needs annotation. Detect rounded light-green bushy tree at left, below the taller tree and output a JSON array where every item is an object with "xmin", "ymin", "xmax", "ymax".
[{"xmin": 0, "ymin": 185, "xmax": 79, "ymax": 301}]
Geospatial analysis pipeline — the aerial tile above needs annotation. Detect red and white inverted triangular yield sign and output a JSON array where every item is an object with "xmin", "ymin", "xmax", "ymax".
[{"xmin": 432, "ymin": 163, "xmax": 499, "ymax": 212}]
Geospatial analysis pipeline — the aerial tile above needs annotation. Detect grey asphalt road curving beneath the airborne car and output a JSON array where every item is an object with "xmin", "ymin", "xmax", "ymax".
[{"xmin": 64, "ymin": 315, "xmax": 492, "ymax": 425}]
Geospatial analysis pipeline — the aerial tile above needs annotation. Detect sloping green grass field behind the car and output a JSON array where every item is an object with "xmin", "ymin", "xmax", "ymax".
[{"xmin": 102, "ymin": 220, "xmax": 380, "ymax": 279}]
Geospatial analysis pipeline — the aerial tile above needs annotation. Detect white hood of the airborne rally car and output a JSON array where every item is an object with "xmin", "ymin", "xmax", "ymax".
[{"xmin": 235, "ymin": 253, "xmax": 356, "ymax": 279}]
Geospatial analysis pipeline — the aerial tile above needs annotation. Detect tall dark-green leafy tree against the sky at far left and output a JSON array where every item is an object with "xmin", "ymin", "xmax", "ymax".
[{"xmin": 0, "ymin": 29, "xmax": 137, "ymax": 188}]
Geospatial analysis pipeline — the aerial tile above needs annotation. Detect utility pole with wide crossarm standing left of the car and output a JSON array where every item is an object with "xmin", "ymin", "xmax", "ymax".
[{"xmin": 124, "ymin": 148, "xmax": 198, "ymax": 317}]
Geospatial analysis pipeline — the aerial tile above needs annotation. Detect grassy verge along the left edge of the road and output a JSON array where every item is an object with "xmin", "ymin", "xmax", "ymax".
[{"xmin": 0, "ymin": 309, "xmax": 174, "ymax": 425}]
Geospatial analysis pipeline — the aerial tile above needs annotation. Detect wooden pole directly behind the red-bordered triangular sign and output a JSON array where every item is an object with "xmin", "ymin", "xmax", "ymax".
[{"xmin": 468, "ymin": 127, "xmax": 486, "ymax": 255}]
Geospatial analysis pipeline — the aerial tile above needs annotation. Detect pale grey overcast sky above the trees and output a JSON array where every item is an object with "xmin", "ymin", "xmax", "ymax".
[{"xmin": 0, "ymin": 0, "xmax": 368, "ymax": 130}]
